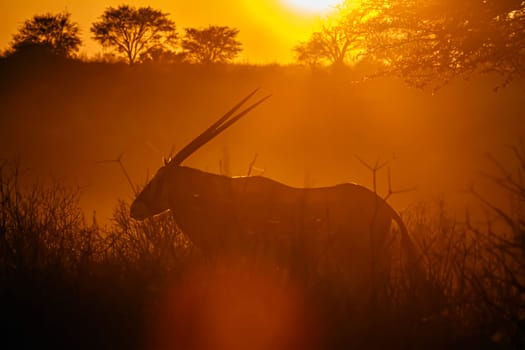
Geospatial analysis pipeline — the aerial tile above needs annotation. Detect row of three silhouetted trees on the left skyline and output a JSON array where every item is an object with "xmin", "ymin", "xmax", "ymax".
[{"xmin": 3, "ymin": 5, "xmax": 242, "ymax": 65}]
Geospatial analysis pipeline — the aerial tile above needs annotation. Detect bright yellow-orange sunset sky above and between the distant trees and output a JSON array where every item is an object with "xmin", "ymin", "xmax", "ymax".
[{"xmin": 0, "ymin": 0, "xmax": 338, "ymax": 63}]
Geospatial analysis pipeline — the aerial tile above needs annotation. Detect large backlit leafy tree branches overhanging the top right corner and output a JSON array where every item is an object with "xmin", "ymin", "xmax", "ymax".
[{"xmin": 328, "ymin": 0, "xmax": 525, "ymax": 88}]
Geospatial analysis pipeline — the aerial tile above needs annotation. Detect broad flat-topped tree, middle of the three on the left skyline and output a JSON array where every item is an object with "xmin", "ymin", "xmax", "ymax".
[{"xmin": 91, "ymin": 5, "xmax": 177, "ymax": 64}]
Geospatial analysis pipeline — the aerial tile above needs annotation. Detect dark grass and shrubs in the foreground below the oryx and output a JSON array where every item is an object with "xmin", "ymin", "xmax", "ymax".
[{"xmin": 0, "ymin": 148, "xmax": 525, "ymax": 349}]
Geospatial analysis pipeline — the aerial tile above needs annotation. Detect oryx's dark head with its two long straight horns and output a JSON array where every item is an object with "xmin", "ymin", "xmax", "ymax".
[{"xmin": 130, "ymin": 89, "xmax": 270, "ymax": 220}]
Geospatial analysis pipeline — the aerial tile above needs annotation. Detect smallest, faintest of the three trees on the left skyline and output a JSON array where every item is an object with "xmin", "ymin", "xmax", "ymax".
[{"xmin": 182, "ymin": 25, "xmax": 242, "ymax": 64}]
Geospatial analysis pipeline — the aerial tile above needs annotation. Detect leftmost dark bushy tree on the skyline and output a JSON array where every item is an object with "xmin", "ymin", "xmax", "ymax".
[{"xmin": 10, "ymin": 12, "xmax": 82, "ymax": 57}]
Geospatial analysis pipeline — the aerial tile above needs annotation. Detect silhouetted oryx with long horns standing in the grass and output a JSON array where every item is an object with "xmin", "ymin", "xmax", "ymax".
[{"xmin": 131, "ymin": 90, "xmax": 418, "ymax": 284}]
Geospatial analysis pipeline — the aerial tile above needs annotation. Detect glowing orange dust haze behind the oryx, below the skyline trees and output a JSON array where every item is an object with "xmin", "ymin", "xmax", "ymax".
[{"xmin": 0, "ymin": 59, "xmax": 525, "ymax": 220}]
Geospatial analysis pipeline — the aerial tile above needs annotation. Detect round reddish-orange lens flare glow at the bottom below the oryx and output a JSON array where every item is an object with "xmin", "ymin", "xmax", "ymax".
[{"xmin": 147, "ymin": 262, "xmax": 320, "ymax": 350}]
